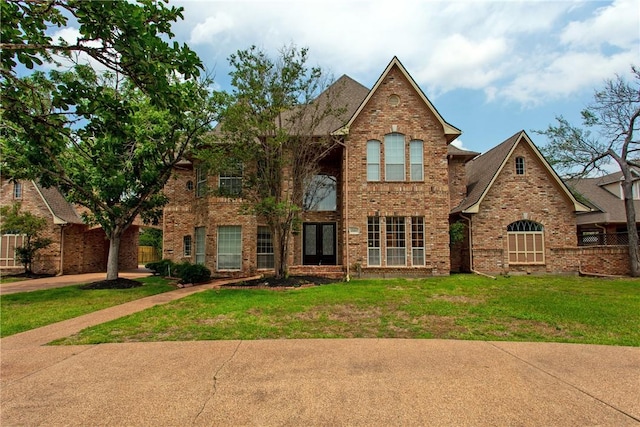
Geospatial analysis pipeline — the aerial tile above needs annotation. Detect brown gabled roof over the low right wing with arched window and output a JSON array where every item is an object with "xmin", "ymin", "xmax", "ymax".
[{"xmin": 452, "ymin": 131, "xmax": 590, "ymax": 213}]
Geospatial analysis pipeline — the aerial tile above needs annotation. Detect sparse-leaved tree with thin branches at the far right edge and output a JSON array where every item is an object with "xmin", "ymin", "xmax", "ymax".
[{"xmin": 538, "ymin": 67, "xmax": 640, "ymax": 276}]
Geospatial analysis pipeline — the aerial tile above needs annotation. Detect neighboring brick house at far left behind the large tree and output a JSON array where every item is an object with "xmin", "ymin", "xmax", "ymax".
[{"xmin": 0, "ymin": 177, "xmax": 138, "ymax": 275}]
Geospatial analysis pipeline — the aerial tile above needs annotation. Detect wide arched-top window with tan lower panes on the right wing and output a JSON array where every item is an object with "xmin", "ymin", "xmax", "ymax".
[{"xmin": 507, "ymin": 220, "xmax": 544, "ymax": 264}]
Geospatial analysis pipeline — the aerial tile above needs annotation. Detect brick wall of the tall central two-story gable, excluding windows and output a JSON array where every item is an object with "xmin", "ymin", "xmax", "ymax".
[{"xmin": 344, "ymin": 67, "xmax": 450, "ymax": 275}]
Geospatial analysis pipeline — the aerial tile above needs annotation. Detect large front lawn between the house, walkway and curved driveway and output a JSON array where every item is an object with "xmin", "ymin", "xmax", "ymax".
[{"xmin": 57, "ymin": 275, "xmax": 640, "ymax": 346}]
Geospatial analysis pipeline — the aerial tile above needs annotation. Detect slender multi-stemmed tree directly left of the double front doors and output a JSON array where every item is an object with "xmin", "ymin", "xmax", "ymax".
[{"xmin": 199, "ymin": 46, "xmax": 344, "ymax": 277}]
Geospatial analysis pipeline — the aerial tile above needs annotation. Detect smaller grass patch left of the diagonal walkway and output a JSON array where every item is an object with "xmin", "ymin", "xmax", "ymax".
[{"xmin": 0, "ymin": 277, "xmax": 175, "ymax": 337}]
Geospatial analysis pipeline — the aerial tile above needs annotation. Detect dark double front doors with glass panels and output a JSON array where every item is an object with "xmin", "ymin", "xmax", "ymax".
[{"xmin": 302, "ymin": 222, "xmax": 336, "ymax": 265}]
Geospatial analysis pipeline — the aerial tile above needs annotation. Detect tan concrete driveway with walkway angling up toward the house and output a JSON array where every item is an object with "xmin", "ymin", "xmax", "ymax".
[{"xmin": 0, "ymin": 276, "xmax": 640, "ymax": 426}]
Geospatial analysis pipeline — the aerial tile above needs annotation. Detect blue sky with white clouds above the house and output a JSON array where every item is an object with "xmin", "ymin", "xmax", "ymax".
[{"xmin": 164, "ymin": 0, "xmax": 640, "ymax": 152}]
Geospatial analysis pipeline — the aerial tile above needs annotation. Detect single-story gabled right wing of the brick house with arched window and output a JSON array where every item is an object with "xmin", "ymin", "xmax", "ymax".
[{"xmin": 451, "ymin": 131, "xmax": 590, "ymax": 273}]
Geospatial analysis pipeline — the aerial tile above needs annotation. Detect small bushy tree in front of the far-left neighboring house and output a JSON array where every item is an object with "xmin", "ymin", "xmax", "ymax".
[{"xmin": 0, "ymin": 203, "xmax": 51, "ymax": 275}]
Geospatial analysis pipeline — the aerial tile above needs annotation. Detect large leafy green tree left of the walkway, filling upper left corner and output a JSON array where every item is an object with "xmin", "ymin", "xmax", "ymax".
[{"xmin": 0, "ymin": 0, "xmax": 214, "ymax": 280}]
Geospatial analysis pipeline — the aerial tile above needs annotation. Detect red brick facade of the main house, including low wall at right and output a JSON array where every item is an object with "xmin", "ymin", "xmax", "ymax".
[{"xmin": 163, "ymin": 59, "xmax": 628, "ymax": 277}]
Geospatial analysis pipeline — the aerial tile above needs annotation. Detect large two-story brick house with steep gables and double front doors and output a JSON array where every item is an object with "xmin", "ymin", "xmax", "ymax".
[{"xmin": 163, "ymin": 57, "xmax": 624, "ymax": 277}]
